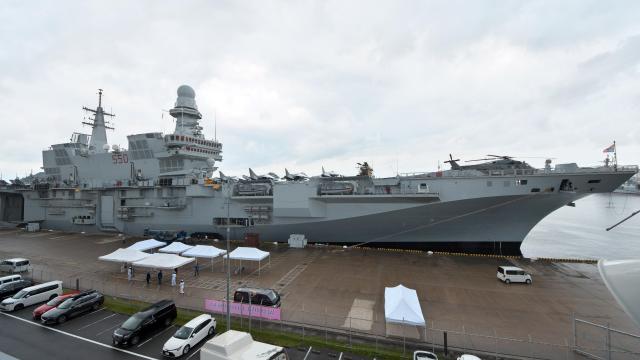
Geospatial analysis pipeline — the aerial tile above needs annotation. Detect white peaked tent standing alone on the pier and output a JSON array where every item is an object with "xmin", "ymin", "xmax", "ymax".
[{"xmin": 384, "ymin": 285, "xmax": 426, "ymax": 326}]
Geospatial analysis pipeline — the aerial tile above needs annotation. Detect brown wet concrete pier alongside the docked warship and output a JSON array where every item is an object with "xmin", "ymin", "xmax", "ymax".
[{"xmin": 0, "ymin": 230, "xmax": 640, "ymax": 359}]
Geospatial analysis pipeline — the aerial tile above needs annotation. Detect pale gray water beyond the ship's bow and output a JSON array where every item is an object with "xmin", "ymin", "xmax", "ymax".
[{"xmin": 520, "ymin": 194, "xmax": 640, "ymax": 259}]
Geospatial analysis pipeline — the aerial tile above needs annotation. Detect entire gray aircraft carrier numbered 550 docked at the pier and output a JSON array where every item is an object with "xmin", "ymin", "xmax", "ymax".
[{"xmin": 0, "ymin": 85, "xmax": 637, "ymax": 254}]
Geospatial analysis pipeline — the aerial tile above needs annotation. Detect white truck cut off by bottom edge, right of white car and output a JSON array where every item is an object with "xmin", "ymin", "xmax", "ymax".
[{"xmin": 200, "ymin": 330, "xmax": 289, "ymax": 360}]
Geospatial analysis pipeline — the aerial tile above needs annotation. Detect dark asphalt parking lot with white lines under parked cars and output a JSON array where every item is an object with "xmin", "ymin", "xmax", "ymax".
[{"xmin": 0, "ymin": 298, "xmax": 365, "ymax": 360}]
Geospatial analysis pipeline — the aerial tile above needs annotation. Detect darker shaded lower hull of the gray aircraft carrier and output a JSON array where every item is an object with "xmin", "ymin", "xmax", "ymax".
[{"xmin": 27, "ymin": 192, "xmax": 586, "ymax": 255}]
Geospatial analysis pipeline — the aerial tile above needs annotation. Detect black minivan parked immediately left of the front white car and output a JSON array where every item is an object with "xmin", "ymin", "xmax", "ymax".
[{"xmin": 113, "ymin": 300, "xmax": 178, "ymax": 346}]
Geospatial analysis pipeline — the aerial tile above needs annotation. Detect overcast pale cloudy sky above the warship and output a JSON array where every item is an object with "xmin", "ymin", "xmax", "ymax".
[{"xmin": 0, "ymin": 0, "xmax": 640, "ymax": 179}]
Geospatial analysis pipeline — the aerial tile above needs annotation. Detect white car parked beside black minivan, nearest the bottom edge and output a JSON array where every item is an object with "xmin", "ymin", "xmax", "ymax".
[{"xmin": 162, "ymin": 314, "xmax": 216, "ymax": 357}]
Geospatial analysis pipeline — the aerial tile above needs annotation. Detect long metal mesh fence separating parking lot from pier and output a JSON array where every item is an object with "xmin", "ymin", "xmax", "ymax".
[{"xmin": 25, "ymin": 267, "xmax": 640, "ymax": 360}]
